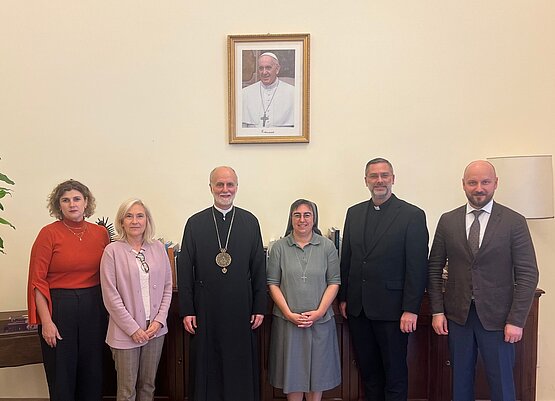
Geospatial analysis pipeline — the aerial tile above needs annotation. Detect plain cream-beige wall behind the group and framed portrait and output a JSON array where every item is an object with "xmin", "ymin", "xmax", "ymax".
[{"xmin": 0, "ymin": 0, "xmax": 555, "ymax": 400}]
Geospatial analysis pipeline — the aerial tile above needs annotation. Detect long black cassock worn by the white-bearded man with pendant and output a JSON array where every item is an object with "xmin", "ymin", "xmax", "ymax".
[{"xmin": 177, "ymin": 207, "xmax": 267, "ymax": 401}]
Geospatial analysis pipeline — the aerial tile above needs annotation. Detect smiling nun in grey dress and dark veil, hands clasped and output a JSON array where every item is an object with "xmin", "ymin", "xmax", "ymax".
[{"xmin": 267, "ymin": 199, "xmax": 341, "ymax": 401}]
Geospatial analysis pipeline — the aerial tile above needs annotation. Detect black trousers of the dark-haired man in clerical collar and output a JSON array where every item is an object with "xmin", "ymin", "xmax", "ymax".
[{"xmin": 347, "ymin": 312, "xmax": 409, "ymax": 401}]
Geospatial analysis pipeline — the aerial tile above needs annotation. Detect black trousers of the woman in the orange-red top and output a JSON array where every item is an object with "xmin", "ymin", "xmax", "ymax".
[{"xmin": 39, "ymin": 286, "xmax": 107, "ymax": 401}]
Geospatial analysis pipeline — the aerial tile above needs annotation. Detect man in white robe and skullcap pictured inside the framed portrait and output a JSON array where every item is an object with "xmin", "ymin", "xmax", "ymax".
[{"xmin": 242, "ymin": 51, "xmax": 295, "ymax": 128}]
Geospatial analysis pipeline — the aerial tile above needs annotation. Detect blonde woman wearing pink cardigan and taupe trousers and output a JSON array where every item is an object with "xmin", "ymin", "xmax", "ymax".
[{"xmin": 100, "ymin": 199, "xmax": 172, "ymax": 401}]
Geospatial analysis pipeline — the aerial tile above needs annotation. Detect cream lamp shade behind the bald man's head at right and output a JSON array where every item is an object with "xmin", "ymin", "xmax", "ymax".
[{"xmin": 488, "ymin": 155, "xmax": 553, "ymax": 219}]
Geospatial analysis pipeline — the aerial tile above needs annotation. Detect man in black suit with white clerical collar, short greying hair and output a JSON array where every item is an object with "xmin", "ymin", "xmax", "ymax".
[{"xmin": 339, "ymin": 158, "xmax": 428, "ymax": 401}]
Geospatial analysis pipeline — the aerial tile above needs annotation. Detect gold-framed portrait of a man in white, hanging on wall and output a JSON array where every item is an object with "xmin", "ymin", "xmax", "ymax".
[{"xmin": 227, "ymin": 33, "xmax": 310, "ymax": 143}]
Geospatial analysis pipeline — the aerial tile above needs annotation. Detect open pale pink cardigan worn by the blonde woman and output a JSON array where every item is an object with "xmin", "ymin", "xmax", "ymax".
[{"xmin": 100, "ymin": 241, "xmax": 172, "ymax": 349}]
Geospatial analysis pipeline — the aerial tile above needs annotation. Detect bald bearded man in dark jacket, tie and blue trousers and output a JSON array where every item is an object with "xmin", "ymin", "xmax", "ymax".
[{"xmin": 428, "ymin": 160, "xmax": 538, "ymax": 401}]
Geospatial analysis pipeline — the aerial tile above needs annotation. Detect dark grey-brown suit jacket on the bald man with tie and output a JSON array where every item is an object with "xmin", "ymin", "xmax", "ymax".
[{"xmin": 428, "ymin": 202, "xmax": 538, "ymax": 330}]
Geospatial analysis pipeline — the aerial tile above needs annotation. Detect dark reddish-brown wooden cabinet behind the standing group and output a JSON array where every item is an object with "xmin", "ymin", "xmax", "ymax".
[{"xmin": 117, "ymin": 290, "xmax": 543, "ymax": 401}]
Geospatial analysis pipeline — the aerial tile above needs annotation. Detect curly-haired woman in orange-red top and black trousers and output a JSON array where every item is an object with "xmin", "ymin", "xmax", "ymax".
[{"xmin": 27, "ymin": 180, "xmax": 110, "ymax": 401}]
